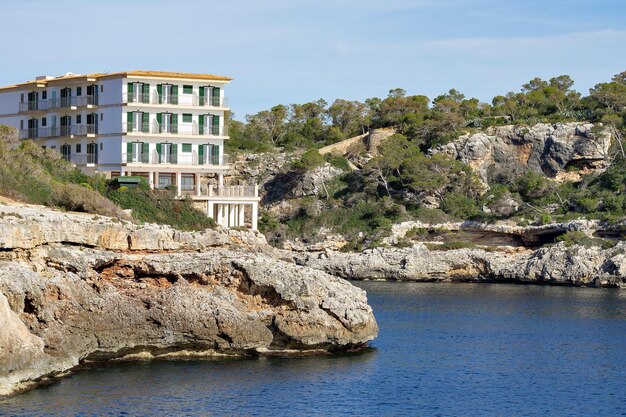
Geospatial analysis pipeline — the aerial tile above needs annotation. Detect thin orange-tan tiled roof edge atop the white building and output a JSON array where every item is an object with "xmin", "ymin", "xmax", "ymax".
[{"xmin": 0, "ymin": 70, "xmax": 232, "ymax": 91}]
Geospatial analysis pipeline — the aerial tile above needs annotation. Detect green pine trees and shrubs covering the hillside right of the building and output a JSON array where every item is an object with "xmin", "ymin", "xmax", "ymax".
[{"xmin": 228, "ymin": 72, "xmax": 626, "ymax": 248}]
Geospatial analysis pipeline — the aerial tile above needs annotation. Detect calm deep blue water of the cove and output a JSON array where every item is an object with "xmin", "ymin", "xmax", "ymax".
[{"xmin": 0, "ymin": 282, "xmax": 626, "ymax": 416}]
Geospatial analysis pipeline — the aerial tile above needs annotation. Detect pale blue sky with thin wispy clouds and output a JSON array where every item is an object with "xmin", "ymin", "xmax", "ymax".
[{"xmin": 0, "ymin": 0, "xmax": 626, "ymax": 119}]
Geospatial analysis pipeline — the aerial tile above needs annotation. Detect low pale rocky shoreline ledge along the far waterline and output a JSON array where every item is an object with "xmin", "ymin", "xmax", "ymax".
[{"xmin": 285, "ymin": 242, "xmax": 626, "ymax": 288}]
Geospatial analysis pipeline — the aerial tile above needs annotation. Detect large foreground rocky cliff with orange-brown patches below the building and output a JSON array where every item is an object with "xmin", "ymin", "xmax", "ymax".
[{"xmin": 0, "ymin": 205, "xmax": 377, "ymax": 394}]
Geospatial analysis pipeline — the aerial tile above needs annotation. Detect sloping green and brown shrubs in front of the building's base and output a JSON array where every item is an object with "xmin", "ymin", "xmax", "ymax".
[{"xmin": 0, "ymin": 133, "xmax": 214, "ymax": 230}]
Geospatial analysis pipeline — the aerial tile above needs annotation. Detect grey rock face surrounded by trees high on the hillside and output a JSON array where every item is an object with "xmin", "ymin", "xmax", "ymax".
[{"xmin": 435, "ymin": 123, "xmax": 611, "ymax": 184}]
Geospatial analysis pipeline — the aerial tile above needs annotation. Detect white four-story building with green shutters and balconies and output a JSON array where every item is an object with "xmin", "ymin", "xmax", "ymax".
[{"xmin": 0, "ymin": 71, "xmax": 259, "ymax": 229}]
